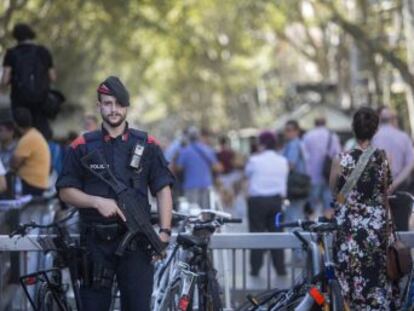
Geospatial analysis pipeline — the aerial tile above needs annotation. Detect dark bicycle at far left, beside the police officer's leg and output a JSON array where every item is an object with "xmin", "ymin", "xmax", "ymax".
[{"xmin": 10, "ymin": 209, "xmax": 83, "ymax": 311}]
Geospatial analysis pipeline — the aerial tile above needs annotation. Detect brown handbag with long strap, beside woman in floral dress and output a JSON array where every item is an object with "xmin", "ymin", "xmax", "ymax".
[{"xmin": 384, "ymin": 171, "xmax": 413, "ymax": 281}]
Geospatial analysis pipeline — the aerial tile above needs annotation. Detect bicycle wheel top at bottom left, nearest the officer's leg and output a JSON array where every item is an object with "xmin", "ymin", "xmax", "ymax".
[{"xmin": 35, "ymin": 282, "xmax": 71, "ymax": 311}]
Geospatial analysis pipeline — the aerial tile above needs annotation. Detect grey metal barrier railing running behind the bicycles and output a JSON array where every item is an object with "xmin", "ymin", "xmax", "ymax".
[{"xmin": 0, "ymin": 232, "xmax": 414, "ymax": 310}]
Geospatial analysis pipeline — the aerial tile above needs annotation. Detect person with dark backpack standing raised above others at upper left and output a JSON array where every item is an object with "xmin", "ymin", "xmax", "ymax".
[{"xmin": 1, "ymin": 24, "xmax": 56, "ymax": 139}]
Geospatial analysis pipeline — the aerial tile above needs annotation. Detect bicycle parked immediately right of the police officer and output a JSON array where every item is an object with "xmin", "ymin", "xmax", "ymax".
[{"xmin": 152, "ymin": 210, "xmax": 241, "ymax": 311}]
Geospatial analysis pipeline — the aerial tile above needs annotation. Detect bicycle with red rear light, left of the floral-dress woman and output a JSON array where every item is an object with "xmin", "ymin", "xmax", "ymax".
[{"xmin": 238, "ymin": 215, "xmax": 345, "ymax": 311}]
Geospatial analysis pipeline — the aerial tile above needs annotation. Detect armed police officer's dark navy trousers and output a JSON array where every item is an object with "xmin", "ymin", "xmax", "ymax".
[{"xmin": 80, "ymin": 225, "xmax": 154, "ymax": 311}]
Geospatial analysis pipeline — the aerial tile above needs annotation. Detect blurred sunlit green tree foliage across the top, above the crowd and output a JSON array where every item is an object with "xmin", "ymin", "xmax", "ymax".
[{"xmin": 0, "ymin": 0, "xmax": 412, "ymax": 136}]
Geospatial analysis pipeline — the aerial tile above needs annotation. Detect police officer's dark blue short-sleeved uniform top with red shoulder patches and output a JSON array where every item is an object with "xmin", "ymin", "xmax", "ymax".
[{"xmin": 56, "ymin": 125, "xmax": 174, "ymax": 221}]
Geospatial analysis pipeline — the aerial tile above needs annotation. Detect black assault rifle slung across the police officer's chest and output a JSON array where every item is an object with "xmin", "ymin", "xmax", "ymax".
[{"xmin": 81, "ymin": 149, "xmax": 165, "ymax": 256}]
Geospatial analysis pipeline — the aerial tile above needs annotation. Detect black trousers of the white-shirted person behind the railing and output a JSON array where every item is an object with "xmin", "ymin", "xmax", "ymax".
[{"xmin": 247, "ymin": 196, "xmax": 286, "ymax": 275}]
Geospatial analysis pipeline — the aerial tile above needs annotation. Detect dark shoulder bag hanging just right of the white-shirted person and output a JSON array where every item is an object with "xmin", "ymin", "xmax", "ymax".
[{"xmin": 287, "ymin": 141, "xmax": 311, "ymax": 200}]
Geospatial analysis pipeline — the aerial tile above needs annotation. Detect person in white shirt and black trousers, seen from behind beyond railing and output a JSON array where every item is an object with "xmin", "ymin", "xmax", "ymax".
[{"xmin": 245, "ymin": 132, "xmax": 289, "ymax": 276}]
